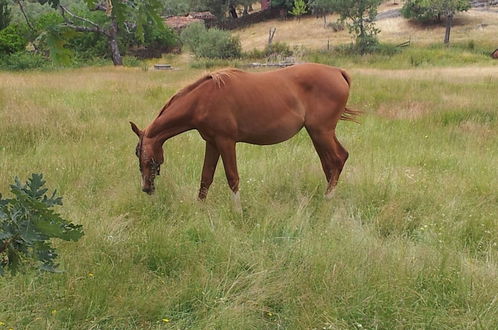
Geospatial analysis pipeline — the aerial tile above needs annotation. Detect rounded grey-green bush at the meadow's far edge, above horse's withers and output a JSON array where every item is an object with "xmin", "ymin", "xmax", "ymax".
[{"xmin": 181, "ymin": 23, "xmax": 242, "ymax": 59}]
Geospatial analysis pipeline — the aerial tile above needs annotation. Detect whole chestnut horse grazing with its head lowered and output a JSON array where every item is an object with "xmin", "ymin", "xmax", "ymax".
[{"xmin": 130, "ymin": 64, "xmax": 359, "ymax": 211}]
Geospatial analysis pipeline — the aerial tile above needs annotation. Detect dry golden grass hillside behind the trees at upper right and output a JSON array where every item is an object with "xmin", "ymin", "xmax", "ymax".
[{"xmin": 235, "ymin": 4, "xmax": 498, "ymax": 50}]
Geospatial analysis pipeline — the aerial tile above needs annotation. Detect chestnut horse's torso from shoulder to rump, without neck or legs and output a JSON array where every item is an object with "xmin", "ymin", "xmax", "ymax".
[{"xmin": 193, "ymin": 64, "xmax": 349, "ymax": 144}]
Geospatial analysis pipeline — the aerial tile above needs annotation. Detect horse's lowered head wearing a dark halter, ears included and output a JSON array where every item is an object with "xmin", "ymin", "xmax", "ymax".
[{"xmin": 130, "ymin": 122, "xmax": 164, "ymax": 195}]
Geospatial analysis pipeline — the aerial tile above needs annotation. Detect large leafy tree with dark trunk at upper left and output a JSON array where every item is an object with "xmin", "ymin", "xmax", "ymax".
[{"xmin": 10, "ymin": 0, "xmax": 174, "ymax": 65}]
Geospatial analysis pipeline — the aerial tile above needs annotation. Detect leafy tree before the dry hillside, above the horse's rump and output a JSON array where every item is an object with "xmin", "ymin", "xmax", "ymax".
[{"xmin": 312, "ymin": 0, "xmax": 382, "ymax": 54}]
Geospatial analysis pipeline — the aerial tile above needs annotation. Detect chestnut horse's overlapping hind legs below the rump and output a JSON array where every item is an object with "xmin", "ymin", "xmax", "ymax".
[{"xmin": 307, "ymin": 128, "xmax": 348, "ymax": 198}]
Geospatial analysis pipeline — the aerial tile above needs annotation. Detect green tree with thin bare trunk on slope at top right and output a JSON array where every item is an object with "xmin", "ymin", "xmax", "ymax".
[{"xmin": 401, "ymin": 0, "xmax": 470, "ymax": 44}]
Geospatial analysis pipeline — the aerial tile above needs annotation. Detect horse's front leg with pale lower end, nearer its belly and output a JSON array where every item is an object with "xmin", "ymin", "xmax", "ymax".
[{"xmin": 216, "ymin": 138, "xmax": 242, "ymax": 213}]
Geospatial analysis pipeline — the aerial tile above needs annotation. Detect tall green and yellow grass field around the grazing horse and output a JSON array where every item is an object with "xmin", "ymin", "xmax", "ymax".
[{"xmin": 0, "ymin": 48, "xmax": 498, "ymax": 329}]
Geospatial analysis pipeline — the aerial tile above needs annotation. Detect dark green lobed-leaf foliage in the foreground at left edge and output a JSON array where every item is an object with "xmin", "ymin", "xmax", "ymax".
[{"xmin": 0, "ymin": 174, "xmax": 83, "ymax": 275}]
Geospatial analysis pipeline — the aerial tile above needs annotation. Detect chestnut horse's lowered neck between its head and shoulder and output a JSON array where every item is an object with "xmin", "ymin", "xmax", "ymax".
[{"xmin": 145, "ymin": 103, "xmax": 193, "ymax": 145}]
